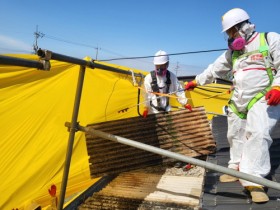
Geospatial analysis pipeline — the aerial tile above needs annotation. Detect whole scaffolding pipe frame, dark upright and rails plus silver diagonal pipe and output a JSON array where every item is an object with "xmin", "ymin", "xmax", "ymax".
[{"xmin": 0, "ymin": 49, "xmax": 280, "ymax": 210}]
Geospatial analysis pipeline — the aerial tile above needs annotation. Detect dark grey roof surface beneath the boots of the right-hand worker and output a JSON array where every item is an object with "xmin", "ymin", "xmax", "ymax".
[{"xmin": 201, "ymin": 116, "xmax": 280, "ymax": 210}]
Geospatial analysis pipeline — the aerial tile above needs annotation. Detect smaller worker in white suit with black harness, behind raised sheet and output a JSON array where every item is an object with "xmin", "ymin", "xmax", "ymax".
[{"xmin": 143, "ymin": 50, "xmax": 192, "ymax": 118}]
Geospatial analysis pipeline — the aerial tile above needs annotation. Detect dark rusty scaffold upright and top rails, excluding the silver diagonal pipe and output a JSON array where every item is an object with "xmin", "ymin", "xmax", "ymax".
[{"xmin": 0, "ymin": 49, "xmax": 144, "ymax": 210}]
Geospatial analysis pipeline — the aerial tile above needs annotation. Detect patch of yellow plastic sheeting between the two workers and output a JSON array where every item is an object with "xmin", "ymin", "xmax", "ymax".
[{"xmin": 186, "ymin": 83, "xmax": 230, "ymax": 120}]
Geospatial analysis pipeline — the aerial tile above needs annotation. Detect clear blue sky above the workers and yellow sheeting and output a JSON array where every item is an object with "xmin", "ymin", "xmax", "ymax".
[{"xmin": 0, "ymin": 0, "xmax": 280, "ymax": 76}]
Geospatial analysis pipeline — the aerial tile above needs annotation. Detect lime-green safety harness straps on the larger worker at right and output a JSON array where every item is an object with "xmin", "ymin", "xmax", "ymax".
[{"xmin": 229, "ymin": 33, "xmax": 273, "ymax": 119}]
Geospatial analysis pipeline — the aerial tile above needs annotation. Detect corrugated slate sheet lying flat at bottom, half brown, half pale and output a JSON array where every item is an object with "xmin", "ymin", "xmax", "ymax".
[{"xmin": 79, "ymin": 170, "xmax": 203, "ymax": 210}]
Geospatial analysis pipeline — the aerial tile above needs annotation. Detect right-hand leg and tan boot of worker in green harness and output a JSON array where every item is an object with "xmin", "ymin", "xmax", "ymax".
[{"xmin": 239, "ymin": 100, "xmax": 280, "ymax": 202}]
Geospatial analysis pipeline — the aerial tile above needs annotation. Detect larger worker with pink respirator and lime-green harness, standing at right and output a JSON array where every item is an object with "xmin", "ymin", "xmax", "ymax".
[{"xmin": 185, "ymin": 8, "xmax": 280, "ymax": 203}]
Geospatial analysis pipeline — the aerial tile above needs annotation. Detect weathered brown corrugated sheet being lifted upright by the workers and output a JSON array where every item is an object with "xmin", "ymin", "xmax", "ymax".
[{"xmin": 86, "ymin": 107, "xmax": 216, "ymax": 178}]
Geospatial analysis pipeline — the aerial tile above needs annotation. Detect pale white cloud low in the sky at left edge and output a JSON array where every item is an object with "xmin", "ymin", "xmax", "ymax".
[{"xmin": 0, "ymin": 34, "xmax": 32, "ymax": 53}]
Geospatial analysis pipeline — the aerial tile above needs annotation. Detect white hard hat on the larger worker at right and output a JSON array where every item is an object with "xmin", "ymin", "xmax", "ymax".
[{"xmin": 222, "ymin": 8, "xmax": 250, "ymax": 32}]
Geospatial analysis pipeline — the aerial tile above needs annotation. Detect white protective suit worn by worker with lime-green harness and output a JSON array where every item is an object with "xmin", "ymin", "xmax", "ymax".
[{"xmin": 195, "ymin": 32, "xmax": 280, "ymax": 186}]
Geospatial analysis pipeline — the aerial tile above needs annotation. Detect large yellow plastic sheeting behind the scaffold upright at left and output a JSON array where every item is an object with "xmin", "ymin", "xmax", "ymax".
[{"xmin": 0, "ymin": 55, "xmax": 146, "ymax": 209}]
